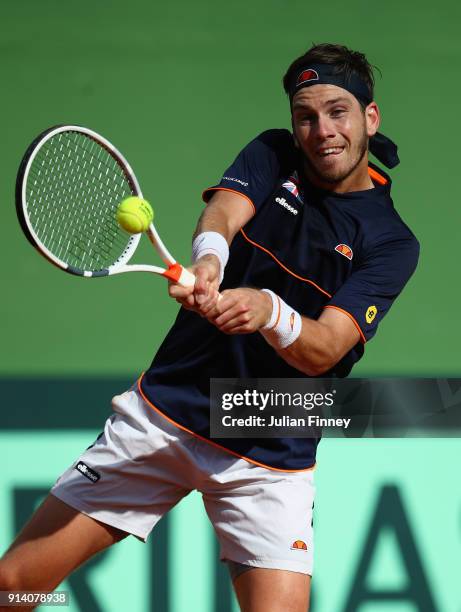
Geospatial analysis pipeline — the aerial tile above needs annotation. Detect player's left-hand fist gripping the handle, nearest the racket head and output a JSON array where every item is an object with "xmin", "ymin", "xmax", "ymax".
[{"xmin": 168, "ymin": 255, "xmax": 221, "ymax": 317}]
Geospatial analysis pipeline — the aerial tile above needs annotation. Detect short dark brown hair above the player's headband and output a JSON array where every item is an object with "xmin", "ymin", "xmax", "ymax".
[{"xmin": 283, "ymin": 43, "xmax": 375, "ymax": 106}]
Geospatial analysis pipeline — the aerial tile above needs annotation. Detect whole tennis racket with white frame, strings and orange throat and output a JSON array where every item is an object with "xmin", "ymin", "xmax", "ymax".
[{"xmin": 16, "ymin": 125, "xmax": 195, "ymax": 286}]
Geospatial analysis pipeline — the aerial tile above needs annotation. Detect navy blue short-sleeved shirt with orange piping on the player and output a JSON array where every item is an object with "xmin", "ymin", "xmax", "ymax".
[{"xmin": 140, "ymin": 130, "xmax": 419, "ymax": 470}]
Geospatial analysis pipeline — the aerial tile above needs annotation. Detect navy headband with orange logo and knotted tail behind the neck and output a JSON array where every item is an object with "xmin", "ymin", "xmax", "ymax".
[{"xmin": 288, "ymin": 64, "xmax": 400, "ymax": 168}]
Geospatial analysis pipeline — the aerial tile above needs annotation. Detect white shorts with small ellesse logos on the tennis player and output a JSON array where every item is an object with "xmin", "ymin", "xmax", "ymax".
[{"xmin": 51, "ymin": 388, "xmax": 315, "ymax": 575}]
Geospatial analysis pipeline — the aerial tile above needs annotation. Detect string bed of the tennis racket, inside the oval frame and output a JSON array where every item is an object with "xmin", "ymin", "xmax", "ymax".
[{"xmin": 26, "ymin": 132, "xmax": 133, "ymax": 271}]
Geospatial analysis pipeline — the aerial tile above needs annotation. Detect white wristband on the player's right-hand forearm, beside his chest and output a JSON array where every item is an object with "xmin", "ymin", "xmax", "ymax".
[{"xmin": 259, "ymin": 289, "xmax": 302, "ymax": 349}]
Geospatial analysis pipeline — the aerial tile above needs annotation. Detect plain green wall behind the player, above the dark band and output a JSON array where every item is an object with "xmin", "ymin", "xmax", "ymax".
[{"xmin": 0, "ymin": 0, "xmax": 461, "ymax": 375}]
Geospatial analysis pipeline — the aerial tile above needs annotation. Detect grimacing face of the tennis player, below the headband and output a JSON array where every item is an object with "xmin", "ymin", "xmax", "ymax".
[{"xmin": 292, "ymin": 85, "xmax": 379, "ymax": 191}]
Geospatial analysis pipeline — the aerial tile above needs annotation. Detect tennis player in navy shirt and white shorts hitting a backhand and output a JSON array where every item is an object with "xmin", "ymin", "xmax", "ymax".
[{"xmin": 0, "ymin": 44, "xmax": 419, "ymax": 612}]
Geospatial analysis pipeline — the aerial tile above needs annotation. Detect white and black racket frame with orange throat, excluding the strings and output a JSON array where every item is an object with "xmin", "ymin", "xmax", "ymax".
[{"xmin": 17, "ymin": 125, "xmax": 195, "ymax": 286}]
